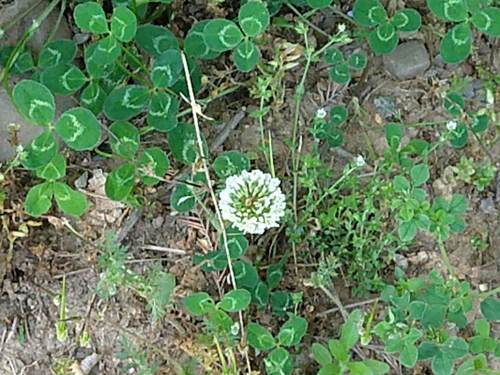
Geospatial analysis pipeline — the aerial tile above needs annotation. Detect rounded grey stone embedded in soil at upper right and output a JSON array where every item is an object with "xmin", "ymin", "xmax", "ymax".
[{"xmin": 383, "ymin": 40, "xmax": 431, "ymax": 80}]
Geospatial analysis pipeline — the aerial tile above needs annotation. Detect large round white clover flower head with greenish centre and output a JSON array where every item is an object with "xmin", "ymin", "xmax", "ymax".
[{"xmin": 220, "ymin": 169, "xmax": 286, "ymax": 234}]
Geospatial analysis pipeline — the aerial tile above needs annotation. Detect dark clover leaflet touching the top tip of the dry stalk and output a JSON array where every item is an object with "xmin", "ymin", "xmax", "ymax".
[{"xmin": 135, "ymin": 24, "xmax": 179, "ymax": 56}]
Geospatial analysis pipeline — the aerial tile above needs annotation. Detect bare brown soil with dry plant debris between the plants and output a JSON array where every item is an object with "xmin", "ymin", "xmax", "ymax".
[{"xmin": 0, "ymin": 1, "xmax": 500, "ymax": 375}]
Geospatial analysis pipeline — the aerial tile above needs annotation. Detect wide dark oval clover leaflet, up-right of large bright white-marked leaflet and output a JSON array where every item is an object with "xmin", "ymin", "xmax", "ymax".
[{"xmin": 104, "ymin": 85, "xmax": 149, "ymax": 121}]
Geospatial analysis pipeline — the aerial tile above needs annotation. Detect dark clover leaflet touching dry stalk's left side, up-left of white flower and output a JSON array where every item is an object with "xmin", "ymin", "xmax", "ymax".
[{"xmin": 168, "ymin": 123, "xmax": 205, "ymax": 164}]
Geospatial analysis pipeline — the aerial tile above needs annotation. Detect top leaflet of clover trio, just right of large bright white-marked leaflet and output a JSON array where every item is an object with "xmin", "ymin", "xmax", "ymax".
[{"xmin": 109, "ymin": 121, "xmax": 140, "ymax": 160}]
